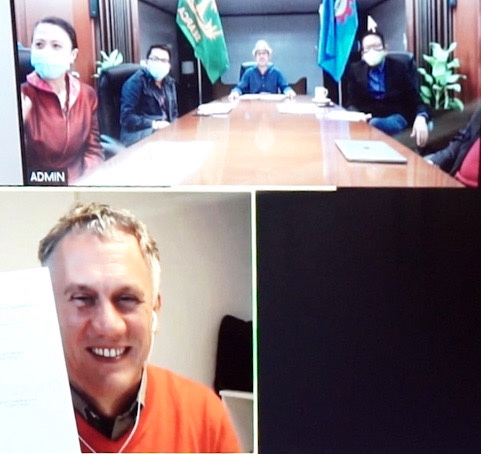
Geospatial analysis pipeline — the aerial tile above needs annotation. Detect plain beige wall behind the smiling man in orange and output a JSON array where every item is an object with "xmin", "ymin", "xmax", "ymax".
[{"xmin": 0, "ymin": 188, "xmax": 252, "ymax": 392}]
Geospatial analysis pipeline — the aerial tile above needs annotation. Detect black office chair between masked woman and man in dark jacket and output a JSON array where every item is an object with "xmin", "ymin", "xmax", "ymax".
[{"xmin": 97, "ymin": 63, "xmax": 142, "ymax": 157}]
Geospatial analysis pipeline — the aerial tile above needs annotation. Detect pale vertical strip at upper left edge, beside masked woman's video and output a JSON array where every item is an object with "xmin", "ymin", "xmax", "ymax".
[{"xmin": 0, "ymin": 0, "xmax": 23, "ymax": 185}]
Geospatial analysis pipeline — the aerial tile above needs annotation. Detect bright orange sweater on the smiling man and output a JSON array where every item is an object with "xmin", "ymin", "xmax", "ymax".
[{"xmin": 75, "ymin": 365, "xmax": 241, "ymax": 453}]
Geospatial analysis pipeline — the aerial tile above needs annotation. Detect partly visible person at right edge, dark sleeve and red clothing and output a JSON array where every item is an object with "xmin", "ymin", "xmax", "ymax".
[{"xmin": 424, "ymin": 106, "xmax": 481, "ymax": 188}]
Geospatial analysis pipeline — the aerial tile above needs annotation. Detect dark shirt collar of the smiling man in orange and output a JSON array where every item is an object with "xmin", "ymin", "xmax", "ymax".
[{"xmin": 70, "ymin": 368, "xmax": 147, "ymax": 440}]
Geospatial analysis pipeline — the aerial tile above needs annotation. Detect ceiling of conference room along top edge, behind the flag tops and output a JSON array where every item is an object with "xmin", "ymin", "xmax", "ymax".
[{"xmin": 148, "ymin": 0, "xmax": 387, "ymax": 16}]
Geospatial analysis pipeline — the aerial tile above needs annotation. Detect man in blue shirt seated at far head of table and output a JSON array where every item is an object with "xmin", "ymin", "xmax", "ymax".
[{"xmin": 229, "ymin": 39, "xmax": 296, "ymax": 101}]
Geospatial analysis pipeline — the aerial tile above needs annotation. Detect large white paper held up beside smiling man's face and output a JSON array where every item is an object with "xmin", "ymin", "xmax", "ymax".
[{"xmin": 0, "ymin": 268, "xmax": 80, "ymax": 453}]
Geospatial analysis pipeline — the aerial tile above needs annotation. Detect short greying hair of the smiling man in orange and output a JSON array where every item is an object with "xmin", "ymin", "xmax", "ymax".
[{"xmin": 38, "ymin": 203, "xmax": 160, "ymax": 297}]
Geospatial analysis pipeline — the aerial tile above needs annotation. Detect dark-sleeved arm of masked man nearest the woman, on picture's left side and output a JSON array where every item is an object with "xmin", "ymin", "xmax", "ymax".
[{"xmin": 120, "ymin": 73, "xmax": 153, "ymax": 131}]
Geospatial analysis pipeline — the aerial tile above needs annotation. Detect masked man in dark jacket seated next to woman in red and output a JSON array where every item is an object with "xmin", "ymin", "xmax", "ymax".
[{"xmin": 120, "ymin": 44, "xmax": 179, "ymax": 146}]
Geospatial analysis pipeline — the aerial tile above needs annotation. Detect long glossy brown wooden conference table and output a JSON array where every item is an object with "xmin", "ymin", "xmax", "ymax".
[{"xmin": 74, "ymin": 96, "xmax": 462, "ymax": 187}]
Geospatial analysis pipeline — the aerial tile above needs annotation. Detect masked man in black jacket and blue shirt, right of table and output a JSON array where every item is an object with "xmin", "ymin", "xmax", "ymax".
[{"xmin": 346, "ymin": 31, "xmax": 430, "ymax": 147}]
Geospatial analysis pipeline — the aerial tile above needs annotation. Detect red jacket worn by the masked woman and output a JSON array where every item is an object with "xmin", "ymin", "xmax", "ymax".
[{"xmin": 21, "ymin": 72, "xmax": 104, "ymax": 182}]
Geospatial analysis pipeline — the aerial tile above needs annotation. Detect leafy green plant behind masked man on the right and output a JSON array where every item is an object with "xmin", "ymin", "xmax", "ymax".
[{"xmin": 418, "ymin": 42, "xmax": 466, "ymax": 110}]
